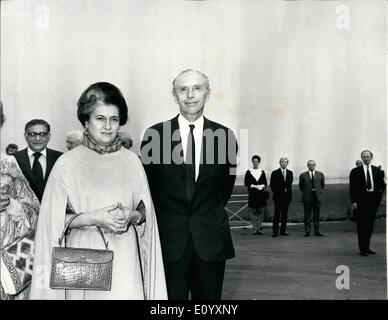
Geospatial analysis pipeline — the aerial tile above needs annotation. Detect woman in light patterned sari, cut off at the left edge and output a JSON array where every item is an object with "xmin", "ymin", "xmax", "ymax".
[{"xmin": 0, "ymin": 101, "xmax": 39, "ymax": 300}]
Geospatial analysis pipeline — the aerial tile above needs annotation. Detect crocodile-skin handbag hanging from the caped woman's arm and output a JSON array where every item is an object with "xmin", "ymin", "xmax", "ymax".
[{"xmin": 50, "ymin": 215, "xmax": 113, "ymax": 291}]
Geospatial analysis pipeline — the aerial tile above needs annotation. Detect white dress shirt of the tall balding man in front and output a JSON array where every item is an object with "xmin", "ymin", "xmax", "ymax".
[{"xmin": 178, "ymin": 114, "xmax": 204, "ymax": 181}]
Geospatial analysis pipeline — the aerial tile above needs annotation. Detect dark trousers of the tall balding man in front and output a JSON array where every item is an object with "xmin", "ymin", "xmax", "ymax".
[{"xmin": 164, "ymin": 236, "xmax": 225, "ymax": 300}]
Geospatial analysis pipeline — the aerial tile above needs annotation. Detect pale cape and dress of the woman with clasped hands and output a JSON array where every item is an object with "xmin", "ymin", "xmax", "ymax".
[{"xmin": 30, "ymin": 145, "xmax": 167, "ymax": 300}]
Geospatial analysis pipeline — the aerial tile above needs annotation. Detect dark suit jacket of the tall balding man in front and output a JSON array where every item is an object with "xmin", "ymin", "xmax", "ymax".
[{"xmin": 141, "ymin": 116, "xmax": 237, "ymax": 261}]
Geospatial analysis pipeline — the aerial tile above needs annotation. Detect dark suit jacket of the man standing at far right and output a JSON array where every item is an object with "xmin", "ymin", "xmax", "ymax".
[{"xmin": 349, "ymin": 166, "xmax": 386, "ymax": 206}]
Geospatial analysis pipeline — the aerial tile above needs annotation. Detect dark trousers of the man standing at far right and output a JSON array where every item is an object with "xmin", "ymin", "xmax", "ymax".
[{"xmin": 356, "ymin": 192, "xmax": 379, "ymax": 253}]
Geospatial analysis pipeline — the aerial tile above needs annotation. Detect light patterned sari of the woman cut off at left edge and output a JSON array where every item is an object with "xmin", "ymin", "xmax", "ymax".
[{"xmin": 0, "ymin": 153, "xmax": 39, "ymax": 300}]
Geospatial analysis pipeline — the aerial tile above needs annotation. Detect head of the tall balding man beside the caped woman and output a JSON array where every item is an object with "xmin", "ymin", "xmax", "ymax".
[{"xmin": 173, "ymin": 71, "xmax": 210, "ymax": 121}]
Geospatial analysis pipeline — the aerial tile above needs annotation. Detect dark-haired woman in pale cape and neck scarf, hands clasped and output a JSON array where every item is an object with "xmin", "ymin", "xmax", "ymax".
[{"xmin": 31, "ymin": 82, "xmax": 167, "ymax": 300}]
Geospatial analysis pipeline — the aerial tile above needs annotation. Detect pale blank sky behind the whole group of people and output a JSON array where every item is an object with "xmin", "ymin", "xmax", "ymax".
[{"xmin": 1, "ymin": 0, "xmax": 386, "ymax": 179}]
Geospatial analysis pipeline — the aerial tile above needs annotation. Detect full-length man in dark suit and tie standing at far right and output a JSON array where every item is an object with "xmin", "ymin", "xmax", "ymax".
[{"xmin": 349, "ymin": 150, "xmax": 386, "ymax": 256}]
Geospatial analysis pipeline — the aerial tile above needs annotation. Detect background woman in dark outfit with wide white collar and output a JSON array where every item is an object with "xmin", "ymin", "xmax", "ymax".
[{"xmin": 244, "ymin": 155, "xmax": 267, "ymax": 235}]
